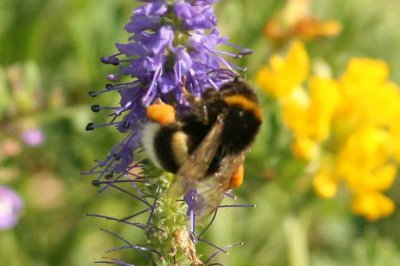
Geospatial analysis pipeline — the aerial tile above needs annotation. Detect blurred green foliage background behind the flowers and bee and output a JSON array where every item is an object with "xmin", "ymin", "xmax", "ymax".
[{"xmin": 0, "ymin": 0, "xmax": 400, "ymax": 266}]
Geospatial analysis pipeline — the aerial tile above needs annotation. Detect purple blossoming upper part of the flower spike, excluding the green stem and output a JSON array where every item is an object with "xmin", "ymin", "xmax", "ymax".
[{"xmin": 87, "ymin": 0, "xmax": 249, "ymax": 188}]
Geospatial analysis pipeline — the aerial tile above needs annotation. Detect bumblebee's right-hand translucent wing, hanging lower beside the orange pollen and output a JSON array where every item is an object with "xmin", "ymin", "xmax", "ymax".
[{"xmin": 194, "ymin": 152, "xmax": 244, "ymax": 220}]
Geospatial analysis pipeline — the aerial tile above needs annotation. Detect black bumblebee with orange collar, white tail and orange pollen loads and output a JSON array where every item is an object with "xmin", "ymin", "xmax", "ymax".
[{"xmin": 142, "ymin": 79, "xmax": 262, "ymax": 219}]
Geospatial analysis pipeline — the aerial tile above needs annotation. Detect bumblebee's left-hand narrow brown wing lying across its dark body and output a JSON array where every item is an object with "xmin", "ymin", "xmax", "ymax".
[{"xmin": 168, "ymin": 114, "xmax": 225, "ymax": 197}]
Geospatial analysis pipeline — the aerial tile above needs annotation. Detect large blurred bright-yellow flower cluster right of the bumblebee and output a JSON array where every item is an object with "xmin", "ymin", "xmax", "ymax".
[{"xmin": 257, "ymin": 42, "xmax": 400, "ymax": 220}]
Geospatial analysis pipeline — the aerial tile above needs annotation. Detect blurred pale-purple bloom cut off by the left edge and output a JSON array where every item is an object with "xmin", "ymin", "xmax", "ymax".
[{"xmin": 0, "ymin": 186, "xmax": 23, "ymax": 230}]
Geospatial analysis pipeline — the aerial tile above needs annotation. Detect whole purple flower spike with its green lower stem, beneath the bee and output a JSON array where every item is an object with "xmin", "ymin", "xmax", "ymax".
[{"xmin": 84, "ymin": 0, "xmax": 251, "ymax": 265}]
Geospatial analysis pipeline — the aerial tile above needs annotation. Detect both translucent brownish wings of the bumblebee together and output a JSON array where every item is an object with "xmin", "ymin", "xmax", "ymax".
[{"xmin": 168, "ymin": 114, "xmax": 245, "ymax": 220}]
